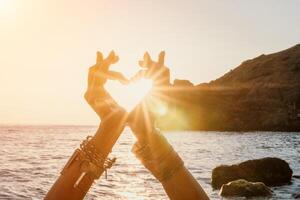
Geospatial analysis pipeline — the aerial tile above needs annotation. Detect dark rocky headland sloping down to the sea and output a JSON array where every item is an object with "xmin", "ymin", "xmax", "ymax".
[{"xmin": 157, "ymin": 44, "xmax": 300, "ymax": 131}]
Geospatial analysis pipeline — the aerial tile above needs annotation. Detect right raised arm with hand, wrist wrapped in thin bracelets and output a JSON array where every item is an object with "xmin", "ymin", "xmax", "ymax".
[{"xmin": 128, "ymin": 51, "xmax": 209, "ymax": 200}]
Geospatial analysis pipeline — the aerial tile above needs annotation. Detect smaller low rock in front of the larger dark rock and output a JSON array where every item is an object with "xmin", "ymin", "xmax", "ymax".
[{"xmin": 220, "ymin": 179, "xmax": 272, "ymax": 197}]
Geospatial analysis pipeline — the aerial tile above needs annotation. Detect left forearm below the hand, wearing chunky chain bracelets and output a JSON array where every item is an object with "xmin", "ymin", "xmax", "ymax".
[{"xmin": 45, "ymin": 111, "xmax": 125, "ymax": 200}]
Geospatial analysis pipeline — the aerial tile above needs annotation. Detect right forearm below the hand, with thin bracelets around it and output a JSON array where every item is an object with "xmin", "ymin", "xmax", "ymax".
[{"xmin": 133, "ymin": 132, "xmax": 209, "ymax": 200}]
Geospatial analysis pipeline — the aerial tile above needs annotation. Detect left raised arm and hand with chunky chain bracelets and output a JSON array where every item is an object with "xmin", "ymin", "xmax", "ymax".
[{"xmin": 45, "ymin": 52, "xmax": 127, "ymax": 200}]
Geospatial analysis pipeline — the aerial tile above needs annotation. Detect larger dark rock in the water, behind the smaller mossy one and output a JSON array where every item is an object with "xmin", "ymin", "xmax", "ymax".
[{"xmin": 212, "ymin": 158, "xmax": 293, "ymax": 189}]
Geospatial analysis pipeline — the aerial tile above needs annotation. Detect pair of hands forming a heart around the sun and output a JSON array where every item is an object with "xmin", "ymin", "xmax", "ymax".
[{"xmin": 84, "ymin": 51, "xmax": 170, "ymax": 142}]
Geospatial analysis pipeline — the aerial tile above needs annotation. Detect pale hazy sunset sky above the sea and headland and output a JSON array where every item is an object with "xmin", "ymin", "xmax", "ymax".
[{"xmin": 0, "ymin": 0, "xmax": 300, "ymax": 124}]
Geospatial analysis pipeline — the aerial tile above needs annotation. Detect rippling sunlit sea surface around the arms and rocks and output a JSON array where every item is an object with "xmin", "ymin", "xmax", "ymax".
[{"xmin": 0, "ymin": 126, "xmax": 300, "ymax": 200}]
